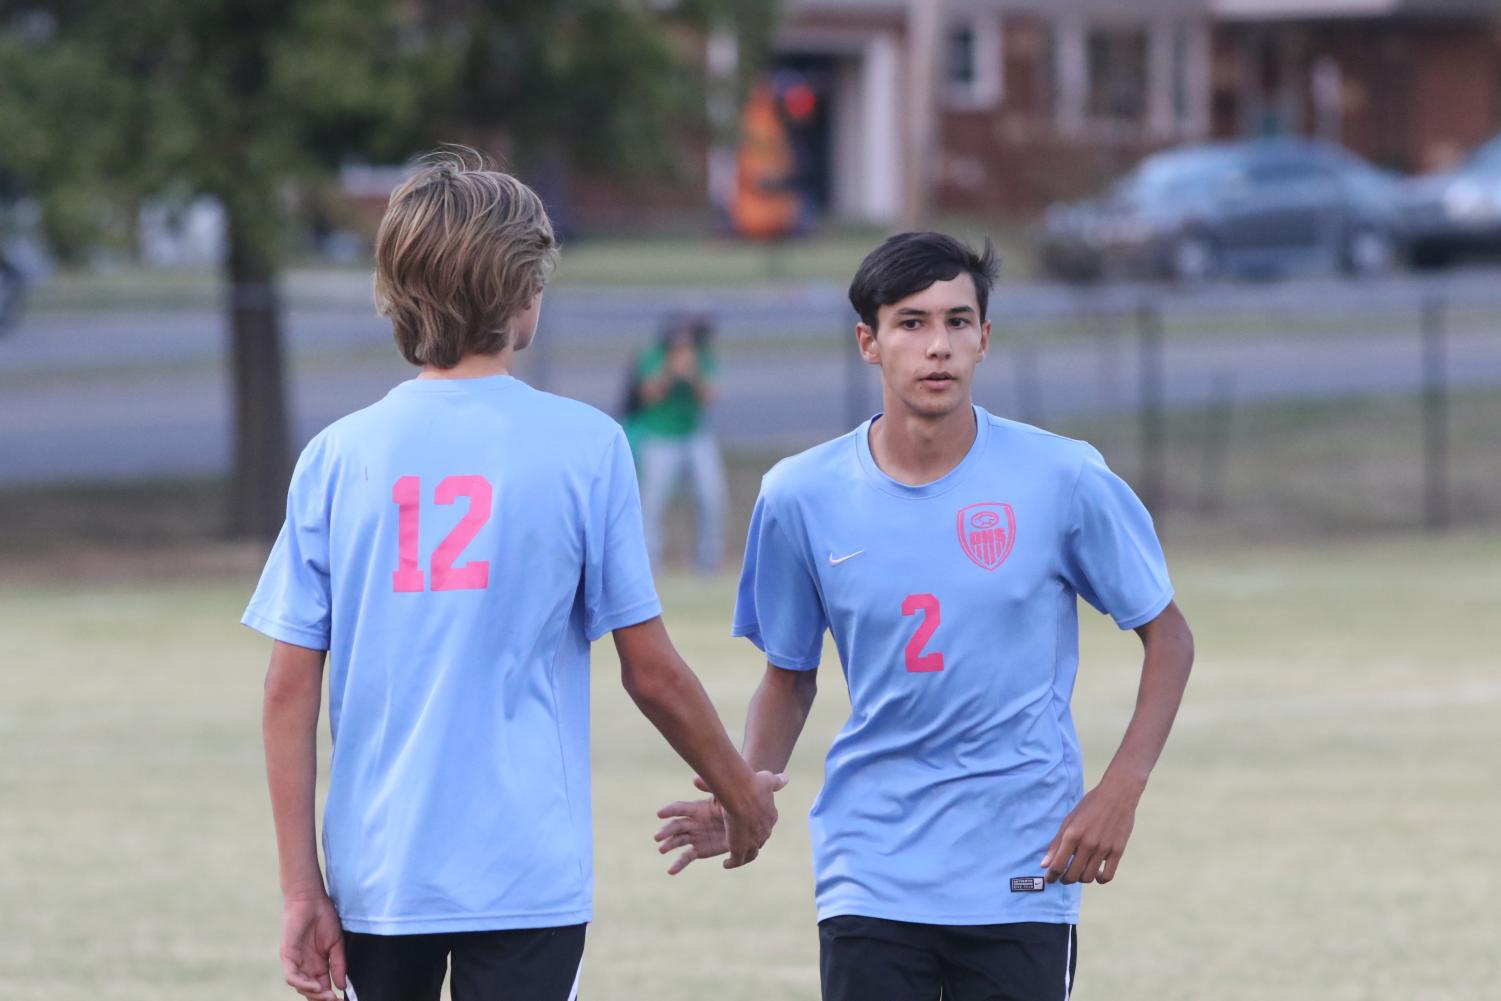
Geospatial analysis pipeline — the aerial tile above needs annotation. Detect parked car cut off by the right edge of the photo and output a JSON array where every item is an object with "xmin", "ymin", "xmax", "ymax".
[{"xmin": 1402, "ymin": 135, "xmax": 1501, "ymax": 267}]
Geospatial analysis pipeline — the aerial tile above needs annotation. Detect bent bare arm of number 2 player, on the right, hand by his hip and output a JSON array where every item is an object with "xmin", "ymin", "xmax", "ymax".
[{"xmin": 1042, "ymin": 603, "xmax": 1193, "ymax": 882}]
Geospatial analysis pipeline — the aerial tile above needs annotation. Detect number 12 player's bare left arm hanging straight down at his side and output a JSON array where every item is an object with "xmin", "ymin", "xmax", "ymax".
[{"xmin": 261, "ymin": 641, "xmax": 345, "ymax": 1001}]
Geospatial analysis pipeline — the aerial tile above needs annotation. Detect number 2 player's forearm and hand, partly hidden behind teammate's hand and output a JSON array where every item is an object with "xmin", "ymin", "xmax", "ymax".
[{"xmin": 656, "ymin": 660, "xmax": 818, "ymax": 876}]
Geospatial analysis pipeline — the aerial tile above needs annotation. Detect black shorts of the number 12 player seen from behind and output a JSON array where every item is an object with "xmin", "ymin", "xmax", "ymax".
[{"xmin": 344, "ymin": 924, "xmax": 585, "ymax": 1001}]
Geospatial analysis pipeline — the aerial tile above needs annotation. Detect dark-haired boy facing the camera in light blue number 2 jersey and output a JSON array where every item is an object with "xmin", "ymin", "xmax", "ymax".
[{"xmin": 657, "ymin": 233, "xmax": 1193, "ymax": 1001}]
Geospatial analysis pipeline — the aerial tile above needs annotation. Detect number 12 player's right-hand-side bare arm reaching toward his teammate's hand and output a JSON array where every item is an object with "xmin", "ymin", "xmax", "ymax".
[{"xmin": 614, "ymin": 617, "xmax": 787, "ymax": 869}]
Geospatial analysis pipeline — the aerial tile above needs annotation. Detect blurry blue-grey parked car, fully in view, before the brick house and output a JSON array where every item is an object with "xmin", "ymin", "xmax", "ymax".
[{"xmin": 1040, "ymin": 138, "xmax": 1403, "ymax": 282}]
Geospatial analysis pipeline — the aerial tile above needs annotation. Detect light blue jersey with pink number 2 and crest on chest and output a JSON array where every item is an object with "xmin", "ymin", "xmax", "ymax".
[{"xmin": 734, "ymin": 407, "xmax": 1172, "ymax": 924}]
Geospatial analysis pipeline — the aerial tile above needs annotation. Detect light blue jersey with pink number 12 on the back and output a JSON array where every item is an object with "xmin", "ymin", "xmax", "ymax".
[{"xmin": 243, "ymin": 375, "xmax": 660, "ymax": 935}]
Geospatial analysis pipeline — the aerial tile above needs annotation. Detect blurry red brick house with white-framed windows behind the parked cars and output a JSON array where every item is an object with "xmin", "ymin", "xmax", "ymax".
[{"xmin": 768, "ymin": 0, "xmax": 1501, "ymax": 224}]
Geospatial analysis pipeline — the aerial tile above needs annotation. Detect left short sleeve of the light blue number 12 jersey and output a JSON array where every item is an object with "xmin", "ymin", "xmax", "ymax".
[{"xmin": 240, "ymin": 440, "xmax": 333, "ymax": 650}]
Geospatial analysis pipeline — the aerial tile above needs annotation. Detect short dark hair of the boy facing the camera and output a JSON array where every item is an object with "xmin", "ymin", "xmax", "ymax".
[{"xmin": 850, "ymin": 233, "xmax": 1000, "ymax": 330}]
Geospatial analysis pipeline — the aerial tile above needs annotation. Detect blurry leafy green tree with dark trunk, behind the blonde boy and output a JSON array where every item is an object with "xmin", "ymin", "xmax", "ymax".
[{"xmin": 0, "ymin": 0, "xmax": 773, "ymax": 537}]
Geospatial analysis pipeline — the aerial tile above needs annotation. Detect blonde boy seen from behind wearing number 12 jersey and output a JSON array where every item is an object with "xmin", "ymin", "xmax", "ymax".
[{"xmin": 243, "ymin": 155, "xmax": 785, "ymax": 1001}]
